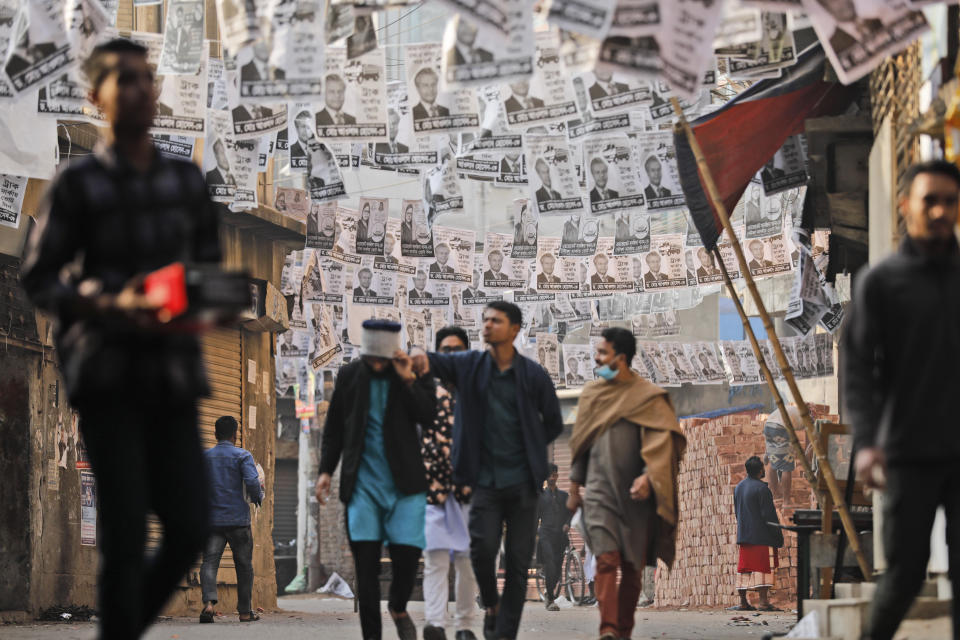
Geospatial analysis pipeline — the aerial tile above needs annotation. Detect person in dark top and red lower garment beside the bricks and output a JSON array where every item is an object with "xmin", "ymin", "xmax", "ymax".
[{"xmin": 730, "ymin": 456, "xmax": 783, "ymax": 611}]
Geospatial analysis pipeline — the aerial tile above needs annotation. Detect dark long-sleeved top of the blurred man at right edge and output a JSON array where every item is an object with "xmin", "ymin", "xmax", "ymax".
[{"xmin": 840, "ymin": 238, "xmax": 960, "ymax": 463}]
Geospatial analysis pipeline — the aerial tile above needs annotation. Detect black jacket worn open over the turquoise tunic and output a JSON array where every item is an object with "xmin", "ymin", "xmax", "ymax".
[{"xmin": 320, "ymin": 360, "xmax": 437, "ymax": 504}]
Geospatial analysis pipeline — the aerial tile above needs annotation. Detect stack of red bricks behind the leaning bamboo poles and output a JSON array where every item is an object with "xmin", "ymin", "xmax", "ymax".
[{"xmin": 655, "ymin": 407, "xmax": 826, "ymax": 608}]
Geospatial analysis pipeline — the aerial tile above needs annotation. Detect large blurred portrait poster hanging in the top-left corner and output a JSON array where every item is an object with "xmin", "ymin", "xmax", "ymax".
[{"xmin": 4, "ymin": 0, "xmax": 76, "ymax": 94}]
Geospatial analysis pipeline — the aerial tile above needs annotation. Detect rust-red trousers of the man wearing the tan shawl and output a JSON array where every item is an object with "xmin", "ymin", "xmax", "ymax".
[{"xmin": 594, "ymin": 551, "xmax": 643, "ymax": 638}]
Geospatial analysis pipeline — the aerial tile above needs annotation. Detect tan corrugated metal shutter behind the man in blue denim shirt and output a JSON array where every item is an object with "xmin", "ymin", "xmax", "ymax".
[{"xmin": 147, "ymin": 329, "xmax": 243, "ymax": 584}]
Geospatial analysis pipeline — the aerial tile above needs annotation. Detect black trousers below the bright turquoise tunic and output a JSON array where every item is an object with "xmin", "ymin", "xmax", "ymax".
[{"xmin": 350, "ymin": 540, "xmax": 420, "ymax": 640}]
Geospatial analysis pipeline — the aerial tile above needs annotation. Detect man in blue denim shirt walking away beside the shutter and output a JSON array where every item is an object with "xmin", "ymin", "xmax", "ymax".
[{"xmin": 200, "ymin": 416, "xmax": 263, "ymax": 622}]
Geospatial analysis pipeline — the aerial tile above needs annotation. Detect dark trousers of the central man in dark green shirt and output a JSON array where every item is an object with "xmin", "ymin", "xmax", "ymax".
[{"xmin": 470, "ymin": 483, "xmax": 537, "ymax": 640}]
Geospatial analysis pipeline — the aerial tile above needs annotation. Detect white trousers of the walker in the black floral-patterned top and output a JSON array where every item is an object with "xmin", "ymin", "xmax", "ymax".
[{"xmin": 423, "ymin": 549, "xmax": 477, "ymax": 631}]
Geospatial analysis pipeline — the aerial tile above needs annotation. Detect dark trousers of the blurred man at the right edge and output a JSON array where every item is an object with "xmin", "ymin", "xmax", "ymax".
[{"xmin": 864, "ymin": 462, "xmax": 960, "ymax": 640}]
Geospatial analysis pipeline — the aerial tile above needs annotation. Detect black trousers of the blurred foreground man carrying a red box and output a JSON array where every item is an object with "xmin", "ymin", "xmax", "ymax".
[{"xmin": 80, "ymin": 398, "xmax": 208, "ymax": 640}]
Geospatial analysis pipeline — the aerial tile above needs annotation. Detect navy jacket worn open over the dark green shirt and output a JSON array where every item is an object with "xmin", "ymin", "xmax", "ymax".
[{"xmin": 428, "ymin": 351, "xmax": 563, "ymax": 491}]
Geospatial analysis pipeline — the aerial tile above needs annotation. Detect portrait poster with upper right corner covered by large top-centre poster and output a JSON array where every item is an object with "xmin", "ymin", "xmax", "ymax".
[{"xmin": 404, "ymin": 43, "xmax": 480, "ymax": 136}]
